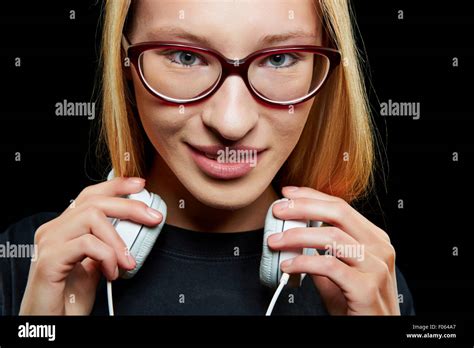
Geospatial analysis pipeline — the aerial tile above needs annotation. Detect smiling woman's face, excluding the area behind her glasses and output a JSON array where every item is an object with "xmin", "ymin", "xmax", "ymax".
[{"xmin": 129, "ymin": 0, "xmax": 321, "ymax": 209}]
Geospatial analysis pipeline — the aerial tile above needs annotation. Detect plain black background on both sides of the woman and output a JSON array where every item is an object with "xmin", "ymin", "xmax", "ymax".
[{"xmin": 0, "ymin": 0, "xmax": 474, "ymax": 315}]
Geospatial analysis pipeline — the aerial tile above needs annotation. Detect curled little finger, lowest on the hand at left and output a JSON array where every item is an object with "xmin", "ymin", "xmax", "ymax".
[{"xmin": 55, "ymin": 234, "xmax": 119, "ymax": 280}]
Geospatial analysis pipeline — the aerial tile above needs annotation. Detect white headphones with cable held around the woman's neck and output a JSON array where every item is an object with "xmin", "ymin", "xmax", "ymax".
[{"xmin": 107, "ymin": 170, "xmax": 322, "ymax": 315}]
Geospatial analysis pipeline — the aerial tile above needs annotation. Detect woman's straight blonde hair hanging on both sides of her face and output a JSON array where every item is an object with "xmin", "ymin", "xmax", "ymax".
[{"xmin": 100, "ymin": 0, "xmax": 375, "ymax": 202}]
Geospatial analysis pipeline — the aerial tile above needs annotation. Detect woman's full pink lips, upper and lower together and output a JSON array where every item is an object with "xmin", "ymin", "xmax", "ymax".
[{"xmin": 186, "ymin": 143, "xmax": 266, "ymax": 180}]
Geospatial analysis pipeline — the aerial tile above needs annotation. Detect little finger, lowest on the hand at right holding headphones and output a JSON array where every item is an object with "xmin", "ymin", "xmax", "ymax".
[{"xmin": 281, "ymin": 255, "xmax": 363, "ymax": 293}]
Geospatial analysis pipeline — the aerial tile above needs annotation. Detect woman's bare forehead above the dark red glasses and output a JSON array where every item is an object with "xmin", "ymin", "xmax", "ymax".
[{"xmin": 132, "ymin": 0, "xmax": 321, "ymax": 57}]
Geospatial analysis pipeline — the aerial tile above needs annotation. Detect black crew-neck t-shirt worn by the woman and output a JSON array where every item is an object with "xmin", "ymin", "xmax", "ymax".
[{"xmin": 0, "ymin": 213, "xmax": 414, "ymax": 315}]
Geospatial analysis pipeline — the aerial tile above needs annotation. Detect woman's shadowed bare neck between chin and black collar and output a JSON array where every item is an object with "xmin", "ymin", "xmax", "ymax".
[{"xmin": 146, "ymin": 155, "xmax": 278, "ymax": 232}]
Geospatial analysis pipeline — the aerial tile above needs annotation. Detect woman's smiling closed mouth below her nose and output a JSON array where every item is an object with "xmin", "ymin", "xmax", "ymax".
[{"xmin": 186, "ymin": 143, "xmax": 266, "ymax": 180}]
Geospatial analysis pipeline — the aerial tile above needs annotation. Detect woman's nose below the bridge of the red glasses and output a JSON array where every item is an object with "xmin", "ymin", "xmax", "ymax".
[{"xmin": 202, "ymin": 75, "xmax": 258, "ymax": 141}]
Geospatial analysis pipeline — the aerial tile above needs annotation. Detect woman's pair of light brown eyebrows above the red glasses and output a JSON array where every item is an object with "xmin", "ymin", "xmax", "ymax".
[{"xmin": 147, "ymin": 26, "xmax": 319, "ymax": 47}]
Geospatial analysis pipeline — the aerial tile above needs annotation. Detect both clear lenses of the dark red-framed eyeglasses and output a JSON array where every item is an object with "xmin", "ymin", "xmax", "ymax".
[{"xmin": 139, "ymin": 47, "xmax": 330, "ymax": 103}]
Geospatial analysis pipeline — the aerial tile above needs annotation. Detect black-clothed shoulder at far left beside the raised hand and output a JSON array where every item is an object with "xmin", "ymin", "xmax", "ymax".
[{"xmin": 0, "ymin": 212, "xmax": 59, "ymax": 315}]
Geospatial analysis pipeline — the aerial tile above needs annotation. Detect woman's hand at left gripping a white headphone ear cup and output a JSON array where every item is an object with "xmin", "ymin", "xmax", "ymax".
[{"xmin": 20, "ymin": 177, "xmax": 162, "ymax": 315}]
